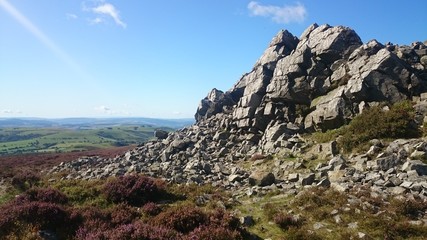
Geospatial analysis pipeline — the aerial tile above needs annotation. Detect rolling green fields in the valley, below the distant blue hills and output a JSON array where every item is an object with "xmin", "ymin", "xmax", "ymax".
[{"xmin": 0, "ymin": 126, "xmax": 171, "ymax": 155}]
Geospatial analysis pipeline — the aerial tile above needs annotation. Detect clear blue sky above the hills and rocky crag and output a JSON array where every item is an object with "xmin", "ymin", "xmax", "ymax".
[{"xmin": 0, "ymin": 0, "xmax": 427, "ymax": 118}]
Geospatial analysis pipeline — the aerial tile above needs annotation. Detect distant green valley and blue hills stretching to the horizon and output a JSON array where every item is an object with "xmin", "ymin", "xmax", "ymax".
[{"xmin": 0, "ymin": 118, "xmax": 193, "ymax": 156}]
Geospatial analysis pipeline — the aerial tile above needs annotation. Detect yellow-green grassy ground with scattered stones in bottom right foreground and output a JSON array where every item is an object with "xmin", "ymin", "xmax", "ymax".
[{"xmin": 235, "ymin": 187, "xmax": 427, "ymax": 239}]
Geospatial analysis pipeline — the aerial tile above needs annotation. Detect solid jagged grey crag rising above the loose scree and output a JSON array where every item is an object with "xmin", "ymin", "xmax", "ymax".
[{"xmin": 196, "ymin": 24, "xmax": 427, "ymax": 142}]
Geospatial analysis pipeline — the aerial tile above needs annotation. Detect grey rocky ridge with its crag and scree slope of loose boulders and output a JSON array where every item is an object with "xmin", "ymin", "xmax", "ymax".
[{"xmin": 49, "ymin": 24, "xmax": 427, "ymax": 201}]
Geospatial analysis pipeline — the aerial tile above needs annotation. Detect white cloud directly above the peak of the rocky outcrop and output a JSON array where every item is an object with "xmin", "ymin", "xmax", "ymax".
[{"xmin": 248, "ymin": 1, "xmax": 307, "ymax": 24}]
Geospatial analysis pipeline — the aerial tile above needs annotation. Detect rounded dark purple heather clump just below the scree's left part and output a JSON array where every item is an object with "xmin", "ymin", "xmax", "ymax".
[{"xmin": 104, "ymin": 175, "xmax": 162, "ymax": 206}]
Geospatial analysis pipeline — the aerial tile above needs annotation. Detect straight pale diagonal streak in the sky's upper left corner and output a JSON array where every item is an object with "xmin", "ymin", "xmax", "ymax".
[{"xmin": 0, "ymin": 0, "xmax": 89, "ymax": 78}]
